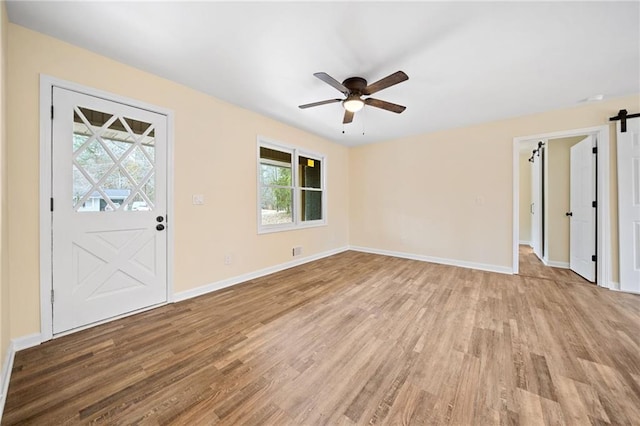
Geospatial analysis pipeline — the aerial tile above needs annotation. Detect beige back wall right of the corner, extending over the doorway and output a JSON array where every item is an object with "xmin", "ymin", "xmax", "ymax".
[{"xmin": 349, "ymin": 95, "xmax": 640, "ymax": 272}]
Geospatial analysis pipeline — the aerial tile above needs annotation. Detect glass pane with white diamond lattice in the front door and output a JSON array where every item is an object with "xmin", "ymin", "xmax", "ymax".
[{"xmin": 73, "ymin": 107, "xmax": 155, "ymax": 212}]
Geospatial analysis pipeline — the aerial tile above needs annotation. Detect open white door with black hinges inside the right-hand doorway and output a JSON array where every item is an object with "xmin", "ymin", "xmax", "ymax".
[{"xmin": 569, "ymin": 136, "xmax": 596, "ymax": 282}]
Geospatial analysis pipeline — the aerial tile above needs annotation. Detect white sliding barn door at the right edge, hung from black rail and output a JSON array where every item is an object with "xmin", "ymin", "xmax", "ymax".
[{"xmin": 617, "ymin": 118, "xmax": 640, "ymax": 293}]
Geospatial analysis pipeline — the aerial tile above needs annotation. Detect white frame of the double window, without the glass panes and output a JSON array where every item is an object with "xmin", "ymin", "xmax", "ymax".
[{"xmin": 256, "ymin": 136, "xmax": 327, "ymax": 234}]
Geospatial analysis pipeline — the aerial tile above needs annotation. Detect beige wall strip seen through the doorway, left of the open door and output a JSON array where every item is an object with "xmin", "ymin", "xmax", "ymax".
[{"xmin": 547, "ymin": 136, "xmax": 585, "ymax": 264}]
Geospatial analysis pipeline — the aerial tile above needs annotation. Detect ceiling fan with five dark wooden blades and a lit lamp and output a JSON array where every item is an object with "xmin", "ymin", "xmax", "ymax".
[{"xmin": 299, "ymin": 71, "xmax": 409, "ymax": 124}]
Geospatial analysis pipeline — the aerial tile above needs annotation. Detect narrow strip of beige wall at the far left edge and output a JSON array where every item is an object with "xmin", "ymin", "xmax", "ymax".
[{"xmin": 0, "ymin": 1, "xmax": 10, "ymax": 365}]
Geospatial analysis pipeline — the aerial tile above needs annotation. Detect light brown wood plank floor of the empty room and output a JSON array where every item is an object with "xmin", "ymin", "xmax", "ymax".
[{"xmin": 2, "ymin": 250, "xmax": 640, "ymax": 425}]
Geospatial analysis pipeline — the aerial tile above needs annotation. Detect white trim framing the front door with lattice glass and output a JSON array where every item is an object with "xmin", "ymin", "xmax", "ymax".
[{"xmin": 39, "ymin": 74, "xmax": 174, "ymax": 341}]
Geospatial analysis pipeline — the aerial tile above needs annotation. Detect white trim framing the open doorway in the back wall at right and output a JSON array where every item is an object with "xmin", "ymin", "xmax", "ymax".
[{"xmin": 511, "ymin": 125, "xmax": 612, "ymax": 288}]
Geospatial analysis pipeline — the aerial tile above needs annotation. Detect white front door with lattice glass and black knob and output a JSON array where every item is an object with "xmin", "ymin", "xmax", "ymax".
[{"xmin": 52, "ymin": 87, "xmax": 167, "ymax": 334}]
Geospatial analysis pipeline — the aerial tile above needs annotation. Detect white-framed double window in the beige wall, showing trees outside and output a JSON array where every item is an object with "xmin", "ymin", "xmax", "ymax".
[{"xmin": 258, "ymin": 140, "xmax": 326, "ymax": 233}]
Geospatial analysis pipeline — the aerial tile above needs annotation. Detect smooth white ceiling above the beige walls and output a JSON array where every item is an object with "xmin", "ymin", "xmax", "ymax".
[{"xmin": 7, "ymin": 1, "xmax": 640, "ymax": 146}]
